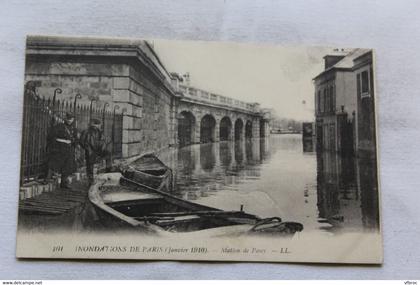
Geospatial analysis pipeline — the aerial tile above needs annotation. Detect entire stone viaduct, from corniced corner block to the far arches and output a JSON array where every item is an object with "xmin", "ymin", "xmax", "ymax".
[{"xmin": 25, "ymin": 36, "xmax": 269, "ymax": 157}]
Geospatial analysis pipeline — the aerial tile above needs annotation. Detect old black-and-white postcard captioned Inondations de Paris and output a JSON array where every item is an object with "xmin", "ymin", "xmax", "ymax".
[{"xmin": 16, "ymin": 36, "xmax": 383, "ymax": 264}]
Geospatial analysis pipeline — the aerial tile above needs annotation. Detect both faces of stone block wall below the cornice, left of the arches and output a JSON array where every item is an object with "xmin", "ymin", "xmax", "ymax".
[{"xmin": 25, "ymin": 54, "xmax": 175, "ymax": 157}]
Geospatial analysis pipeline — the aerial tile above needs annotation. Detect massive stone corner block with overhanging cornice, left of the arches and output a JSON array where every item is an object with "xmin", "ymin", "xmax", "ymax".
[{"xmin": 25, "ymin": 37, "xmax": 176, "ymax": 157}]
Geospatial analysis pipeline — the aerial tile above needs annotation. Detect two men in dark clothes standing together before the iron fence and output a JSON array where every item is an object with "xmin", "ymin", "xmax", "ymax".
[{"xmin": 46, "ymin": 112, "xmax": 112, "ymax": 189}]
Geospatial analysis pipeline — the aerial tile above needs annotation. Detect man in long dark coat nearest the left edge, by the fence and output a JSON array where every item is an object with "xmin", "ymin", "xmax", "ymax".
[{"xmin": 47, "ymin": 113, "xmax": 77, "ymax": 189}]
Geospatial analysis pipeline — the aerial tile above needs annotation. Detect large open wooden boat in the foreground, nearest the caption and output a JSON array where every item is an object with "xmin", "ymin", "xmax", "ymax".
[{"xmin": 89, "ymin": 173, "xmax": 303, "ymax": 236}]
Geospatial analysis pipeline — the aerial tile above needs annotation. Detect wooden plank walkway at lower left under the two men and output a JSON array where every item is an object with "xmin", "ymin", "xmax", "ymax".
[{"xmin": 18, "ymin": 162, "xmax": 120, "ymax": 232}]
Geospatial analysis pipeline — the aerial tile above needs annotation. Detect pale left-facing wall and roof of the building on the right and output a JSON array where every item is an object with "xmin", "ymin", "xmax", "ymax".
[{"xmin": 314, "ymin": 49, "xmax": 368, "ymax": 154}]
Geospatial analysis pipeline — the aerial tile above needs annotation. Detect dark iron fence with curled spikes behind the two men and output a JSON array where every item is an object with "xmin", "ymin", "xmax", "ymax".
[{"xmin": 20, "ymin": 88, "xmax": 124, "ymax": 184}]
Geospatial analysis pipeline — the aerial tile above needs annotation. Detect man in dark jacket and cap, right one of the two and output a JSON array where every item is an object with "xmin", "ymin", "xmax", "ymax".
[{"xmin": 80, "ymin": 119, "xmax": 111, "ymax": 184}]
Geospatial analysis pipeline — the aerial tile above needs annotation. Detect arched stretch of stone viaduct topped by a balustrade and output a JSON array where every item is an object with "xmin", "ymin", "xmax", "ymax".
[{"xmin": 177, "ymin": 85, "xmax": 268, "ymax": 145}]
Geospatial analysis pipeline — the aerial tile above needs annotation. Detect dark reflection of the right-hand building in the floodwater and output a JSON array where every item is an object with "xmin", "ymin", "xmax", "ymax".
[{"xmin": 317, "ymin": 152, "xmax": 379, "ymax": 229}]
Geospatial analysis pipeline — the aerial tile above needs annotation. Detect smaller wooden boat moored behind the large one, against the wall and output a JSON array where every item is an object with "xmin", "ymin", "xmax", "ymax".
[{"xmin": 121, "ymin": 154, "xmax": 172, "ymax": 191}]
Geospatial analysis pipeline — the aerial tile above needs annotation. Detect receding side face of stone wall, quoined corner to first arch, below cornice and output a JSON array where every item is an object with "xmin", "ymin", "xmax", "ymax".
[{"xmin": 118, "ymin": 66, "xmax": 174, "ymax": 157}]
